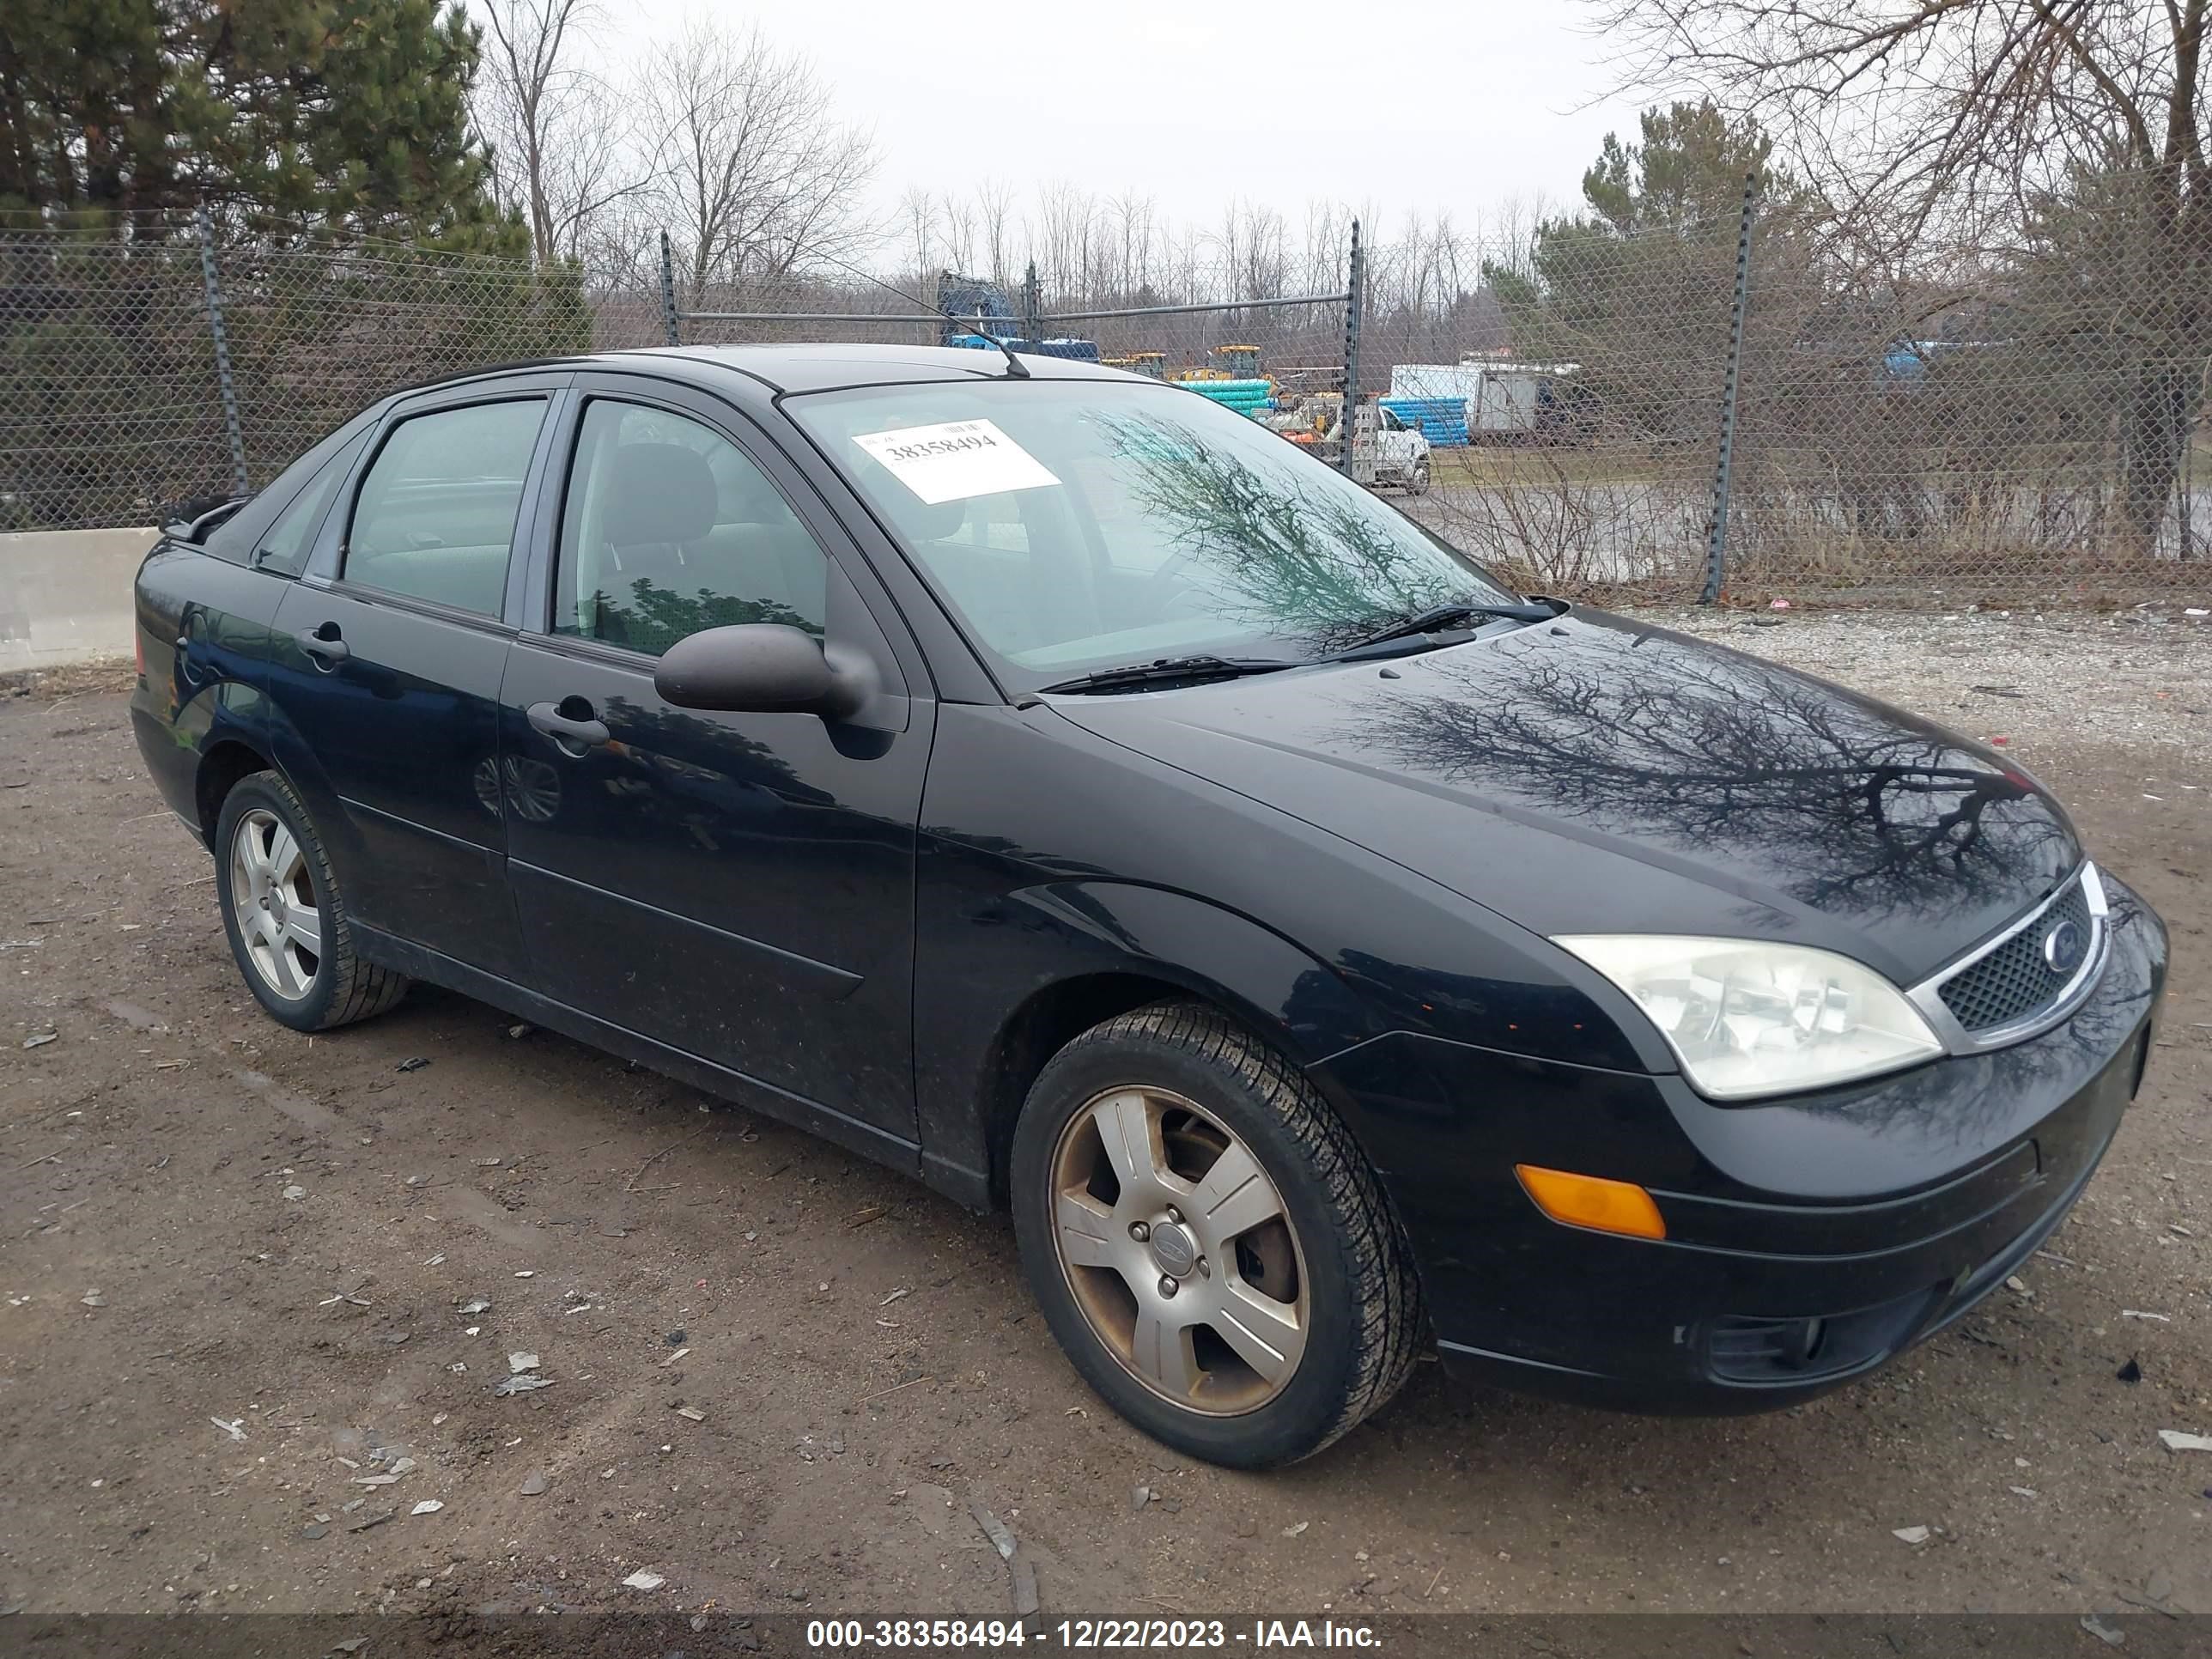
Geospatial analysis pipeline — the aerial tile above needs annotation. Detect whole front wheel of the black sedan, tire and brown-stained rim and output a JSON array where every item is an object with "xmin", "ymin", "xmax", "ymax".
[{"xmin": 1011, "ymin": 1002, "xmax": 1422, "ymax": 1468}]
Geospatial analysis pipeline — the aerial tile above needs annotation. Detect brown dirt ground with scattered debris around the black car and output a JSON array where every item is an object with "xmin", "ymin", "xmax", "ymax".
[{"xmin": 0, "ymin": 630, "xmax": 2212, "ymax": 1641}]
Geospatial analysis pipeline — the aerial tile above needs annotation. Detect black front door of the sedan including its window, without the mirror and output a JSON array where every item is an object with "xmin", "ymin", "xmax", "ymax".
[{"xmin": 500, "ymin": 378, "xmax": 933, "ymax": 1146}]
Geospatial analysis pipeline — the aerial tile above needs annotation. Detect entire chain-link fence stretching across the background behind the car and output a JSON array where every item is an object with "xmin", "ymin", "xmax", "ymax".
[{"xmin": 0, "ymin": 181, "xmax": 2212, "ymax": 608}]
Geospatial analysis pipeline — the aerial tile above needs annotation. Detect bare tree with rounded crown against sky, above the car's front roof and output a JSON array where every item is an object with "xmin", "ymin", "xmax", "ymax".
[{"xmin": 639, "ymin": 20, "xmax": 876, "ymax": 301}]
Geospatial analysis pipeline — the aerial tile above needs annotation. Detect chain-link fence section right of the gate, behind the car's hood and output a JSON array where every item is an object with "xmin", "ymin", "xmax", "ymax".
[{"xmin": 1363, "ymin": 179, "xmax": 2212, "ymax": 608}]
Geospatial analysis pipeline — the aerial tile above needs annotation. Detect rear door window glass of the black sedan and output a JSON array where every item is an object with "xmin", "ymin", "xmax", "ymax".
[{"xmin": 345, "ymin": 398, "xmax": 546, "ymax": 617}]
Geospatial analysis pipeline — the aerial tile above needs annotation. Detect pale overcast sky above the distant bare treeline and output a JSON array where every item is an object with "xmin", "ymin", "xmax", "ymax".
[{"xmin": 579, "ymin": 0, "xmax": 1635, "ymax": 245}]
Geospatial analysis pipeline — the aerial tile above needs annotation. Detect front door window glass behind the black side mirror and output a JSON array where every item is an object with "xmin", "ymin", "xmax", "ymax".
[{"xmin": 553, "ymin": 398, "xmax": 830, "ymax": 657}]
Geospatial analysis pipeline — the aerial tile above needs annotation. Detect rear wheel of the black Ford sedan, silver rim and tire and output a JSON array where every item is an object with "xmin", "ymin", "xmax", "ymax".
[{"xmin": 215, "ymin": 772, "xmax": 407, "ymax": 1030}]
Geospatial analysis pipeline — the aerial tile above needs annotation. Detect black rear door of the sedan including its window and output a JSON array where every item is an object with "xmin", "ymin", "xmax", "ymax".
[{"xmin": 270, "ymin": 374, "xmax": 568, "ymax": 980}]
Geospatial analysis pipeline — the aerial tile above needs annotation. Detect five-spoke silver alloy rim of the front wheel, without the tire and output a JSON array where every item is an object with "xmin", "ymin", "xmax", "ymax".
[{"xmin": 1051, "ymin": 1086, "xmax": 1310, "ymax": 1416}]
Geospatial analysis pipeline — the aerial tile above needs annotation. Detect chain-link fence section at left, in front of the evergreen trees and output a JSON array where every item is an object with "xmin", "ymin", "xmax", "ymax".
[{"xmin": 0, "ymin": 219, "xmax": 659, "ymax": 531}]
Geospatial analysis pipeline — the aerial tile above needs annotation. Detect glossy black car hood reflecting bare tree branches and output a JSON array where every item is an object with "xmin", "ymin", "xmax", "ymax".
[{"xmin": 1053, "ymin": 611, "xmax": 2081, "ymax": 984}]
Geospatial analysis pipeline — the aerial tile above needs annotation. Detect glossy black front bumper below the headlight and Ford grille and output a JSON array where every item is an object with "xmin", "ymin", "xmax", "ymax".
[{"xmin": 1318, "ymin": 878, "xmax": 2166, "ymax": 1413}]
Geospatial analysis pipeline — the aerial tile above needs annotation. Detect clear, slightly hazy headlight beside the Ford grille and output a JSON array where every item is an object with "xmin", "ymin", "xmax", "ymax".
[{"xmin": 1553, "ymin": 933, "xmax": 1942, "ymax": 1099}]
